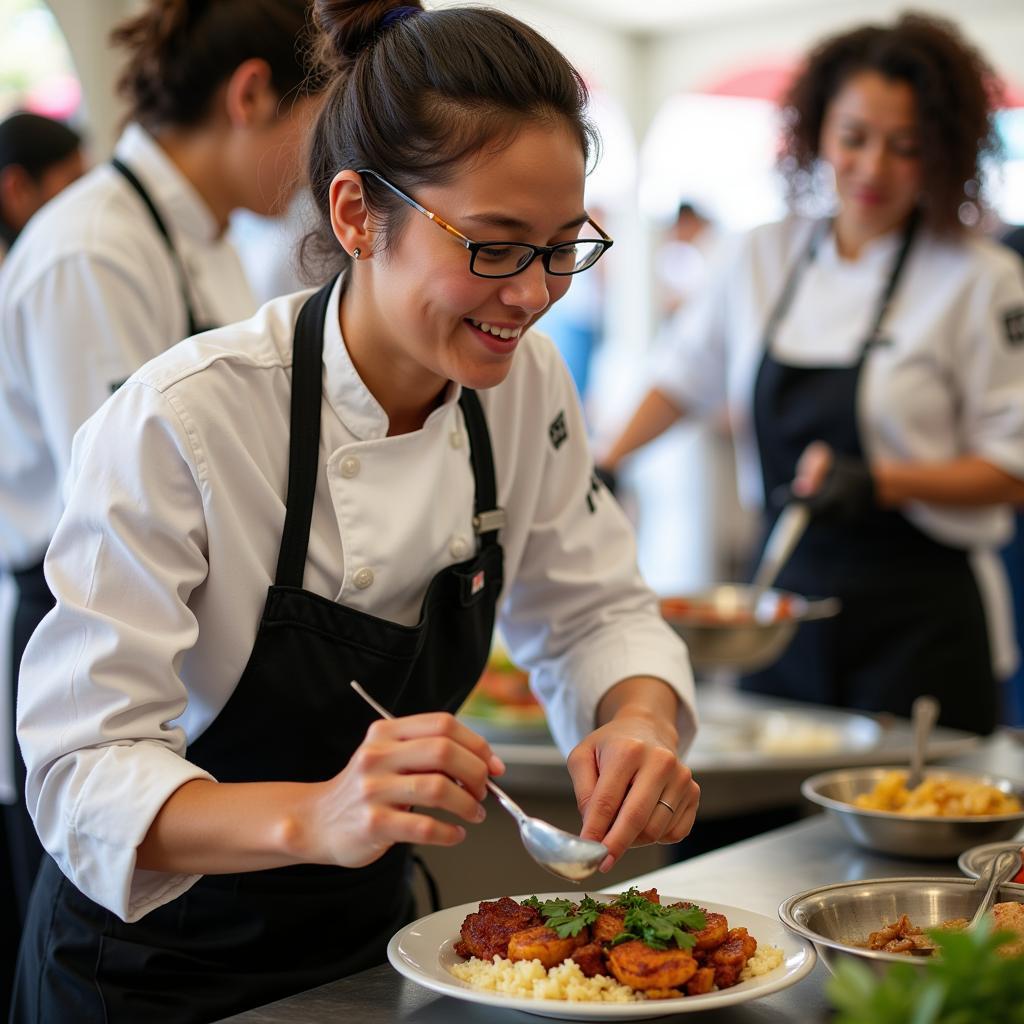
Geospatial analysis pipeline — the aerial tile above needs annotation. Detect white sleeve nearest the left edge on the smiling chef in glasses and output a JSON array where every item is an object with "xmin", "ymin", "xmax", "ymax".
[{"xmin": 17, "ymin": 382, "xmax": 209, "ymax": 922}]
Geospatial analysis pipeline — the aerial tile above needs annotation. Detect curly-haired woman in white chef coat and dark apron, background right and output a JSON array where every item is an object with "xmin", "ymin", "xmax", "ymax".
[{"xmin": 604, "ymin": 15, "xmax": 1024, "ymax": 732}]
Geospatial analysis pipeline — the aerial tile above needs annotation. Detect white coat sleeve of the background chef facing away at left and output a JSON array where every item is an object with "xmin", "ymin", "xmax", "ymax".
[{"xmin": 18, "ymin": 252, "xmax": 182, "ymax": 481}]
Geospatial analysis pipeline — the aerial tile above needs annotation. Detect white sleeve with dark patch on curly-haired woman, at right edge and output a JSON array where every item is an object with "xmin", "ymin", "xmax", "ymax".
[{"xmin": 953, "ymin": 251, "xmax": 1024, "ymax": 479}]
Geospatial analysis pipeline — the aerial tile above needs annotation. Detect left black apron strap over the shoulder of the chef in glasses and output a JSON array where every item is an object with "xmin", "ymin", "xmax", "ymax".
[{"xmin": 275, "ymin": 278, "xmax": 336, "ymax": 590}]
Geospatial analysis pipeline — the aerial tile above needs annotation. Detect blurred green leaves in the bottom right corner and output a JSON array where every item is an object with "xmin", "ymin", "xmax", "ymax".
[{"xmin": 825, "ymin": 924, "xmax": 1024, "ymax": 1024}]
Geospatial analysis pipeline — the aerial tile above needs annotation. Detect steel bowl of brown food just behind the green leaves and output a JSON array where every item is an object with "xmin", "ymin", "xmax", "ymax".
[{"xmin": 778, "ymin": 878, "xmax": 1024, "ymax": 973}]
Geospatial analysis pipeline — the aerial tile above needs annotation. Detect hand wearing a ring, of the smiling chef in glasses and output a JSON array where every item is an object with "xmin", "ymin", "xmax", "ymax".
[{"xmin": 566, "ymin": 679, "xmax": 700, "ymax": 871}]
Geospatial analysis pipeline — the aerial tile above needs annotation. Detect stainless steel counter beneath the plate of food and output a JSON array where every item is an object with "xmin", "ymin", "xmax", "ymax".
[{"xmin": 218, "ymin": 734, "xmax": 1024, "ymax": 1024}]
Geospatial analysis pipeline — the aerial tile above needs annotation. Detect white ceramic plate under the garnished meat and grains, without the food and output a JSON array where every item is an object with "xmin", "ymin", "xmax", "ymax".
[{"xmin": 387, "ymin": 892, "xmax": 816, "ymax": 1021}]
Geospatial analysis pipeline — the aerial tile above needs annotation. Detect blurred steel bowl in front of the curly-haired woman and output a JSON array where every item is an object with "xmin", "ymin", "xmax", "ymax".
[{"xmin": 662, "ymin": 584, "xmax": 840, "ymax": 672}]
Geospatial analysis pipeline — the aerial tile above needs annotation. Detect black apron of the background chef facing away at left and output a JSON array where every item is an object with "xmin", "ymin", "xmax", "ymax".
[{"xmin": 4, "ymin": 158, "xmax": 226, "ymax": 942}]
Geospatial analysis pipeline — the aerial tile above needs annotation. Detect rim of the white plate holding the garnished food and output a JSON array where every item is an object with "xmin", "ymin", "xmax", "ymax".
[{"xmin": 387, "ymin": 890, "xmax": 817, "ymax": 1020}]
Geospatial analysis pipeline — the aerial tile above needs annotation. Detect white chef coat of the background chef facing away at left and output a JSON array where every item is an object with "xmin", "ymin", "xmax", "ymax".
[{"xmin": 0, "ymin": 125, "xmax": 257, "ymax": 568}]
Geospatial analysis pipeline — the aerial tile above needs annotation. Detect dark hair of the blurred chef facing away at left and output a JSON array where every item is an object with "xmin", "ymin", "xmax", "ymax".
[{"xmin": 111, "ymin": 0, "xmax": 323, "ymax": 129}]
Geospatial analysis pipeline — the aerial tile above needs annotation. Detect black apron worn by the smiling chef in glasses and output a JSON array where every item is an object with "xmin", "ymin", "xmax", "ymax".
[{"xmin": 12, "ymin": 285, "xmax": 504, "ymax": 1024}]
